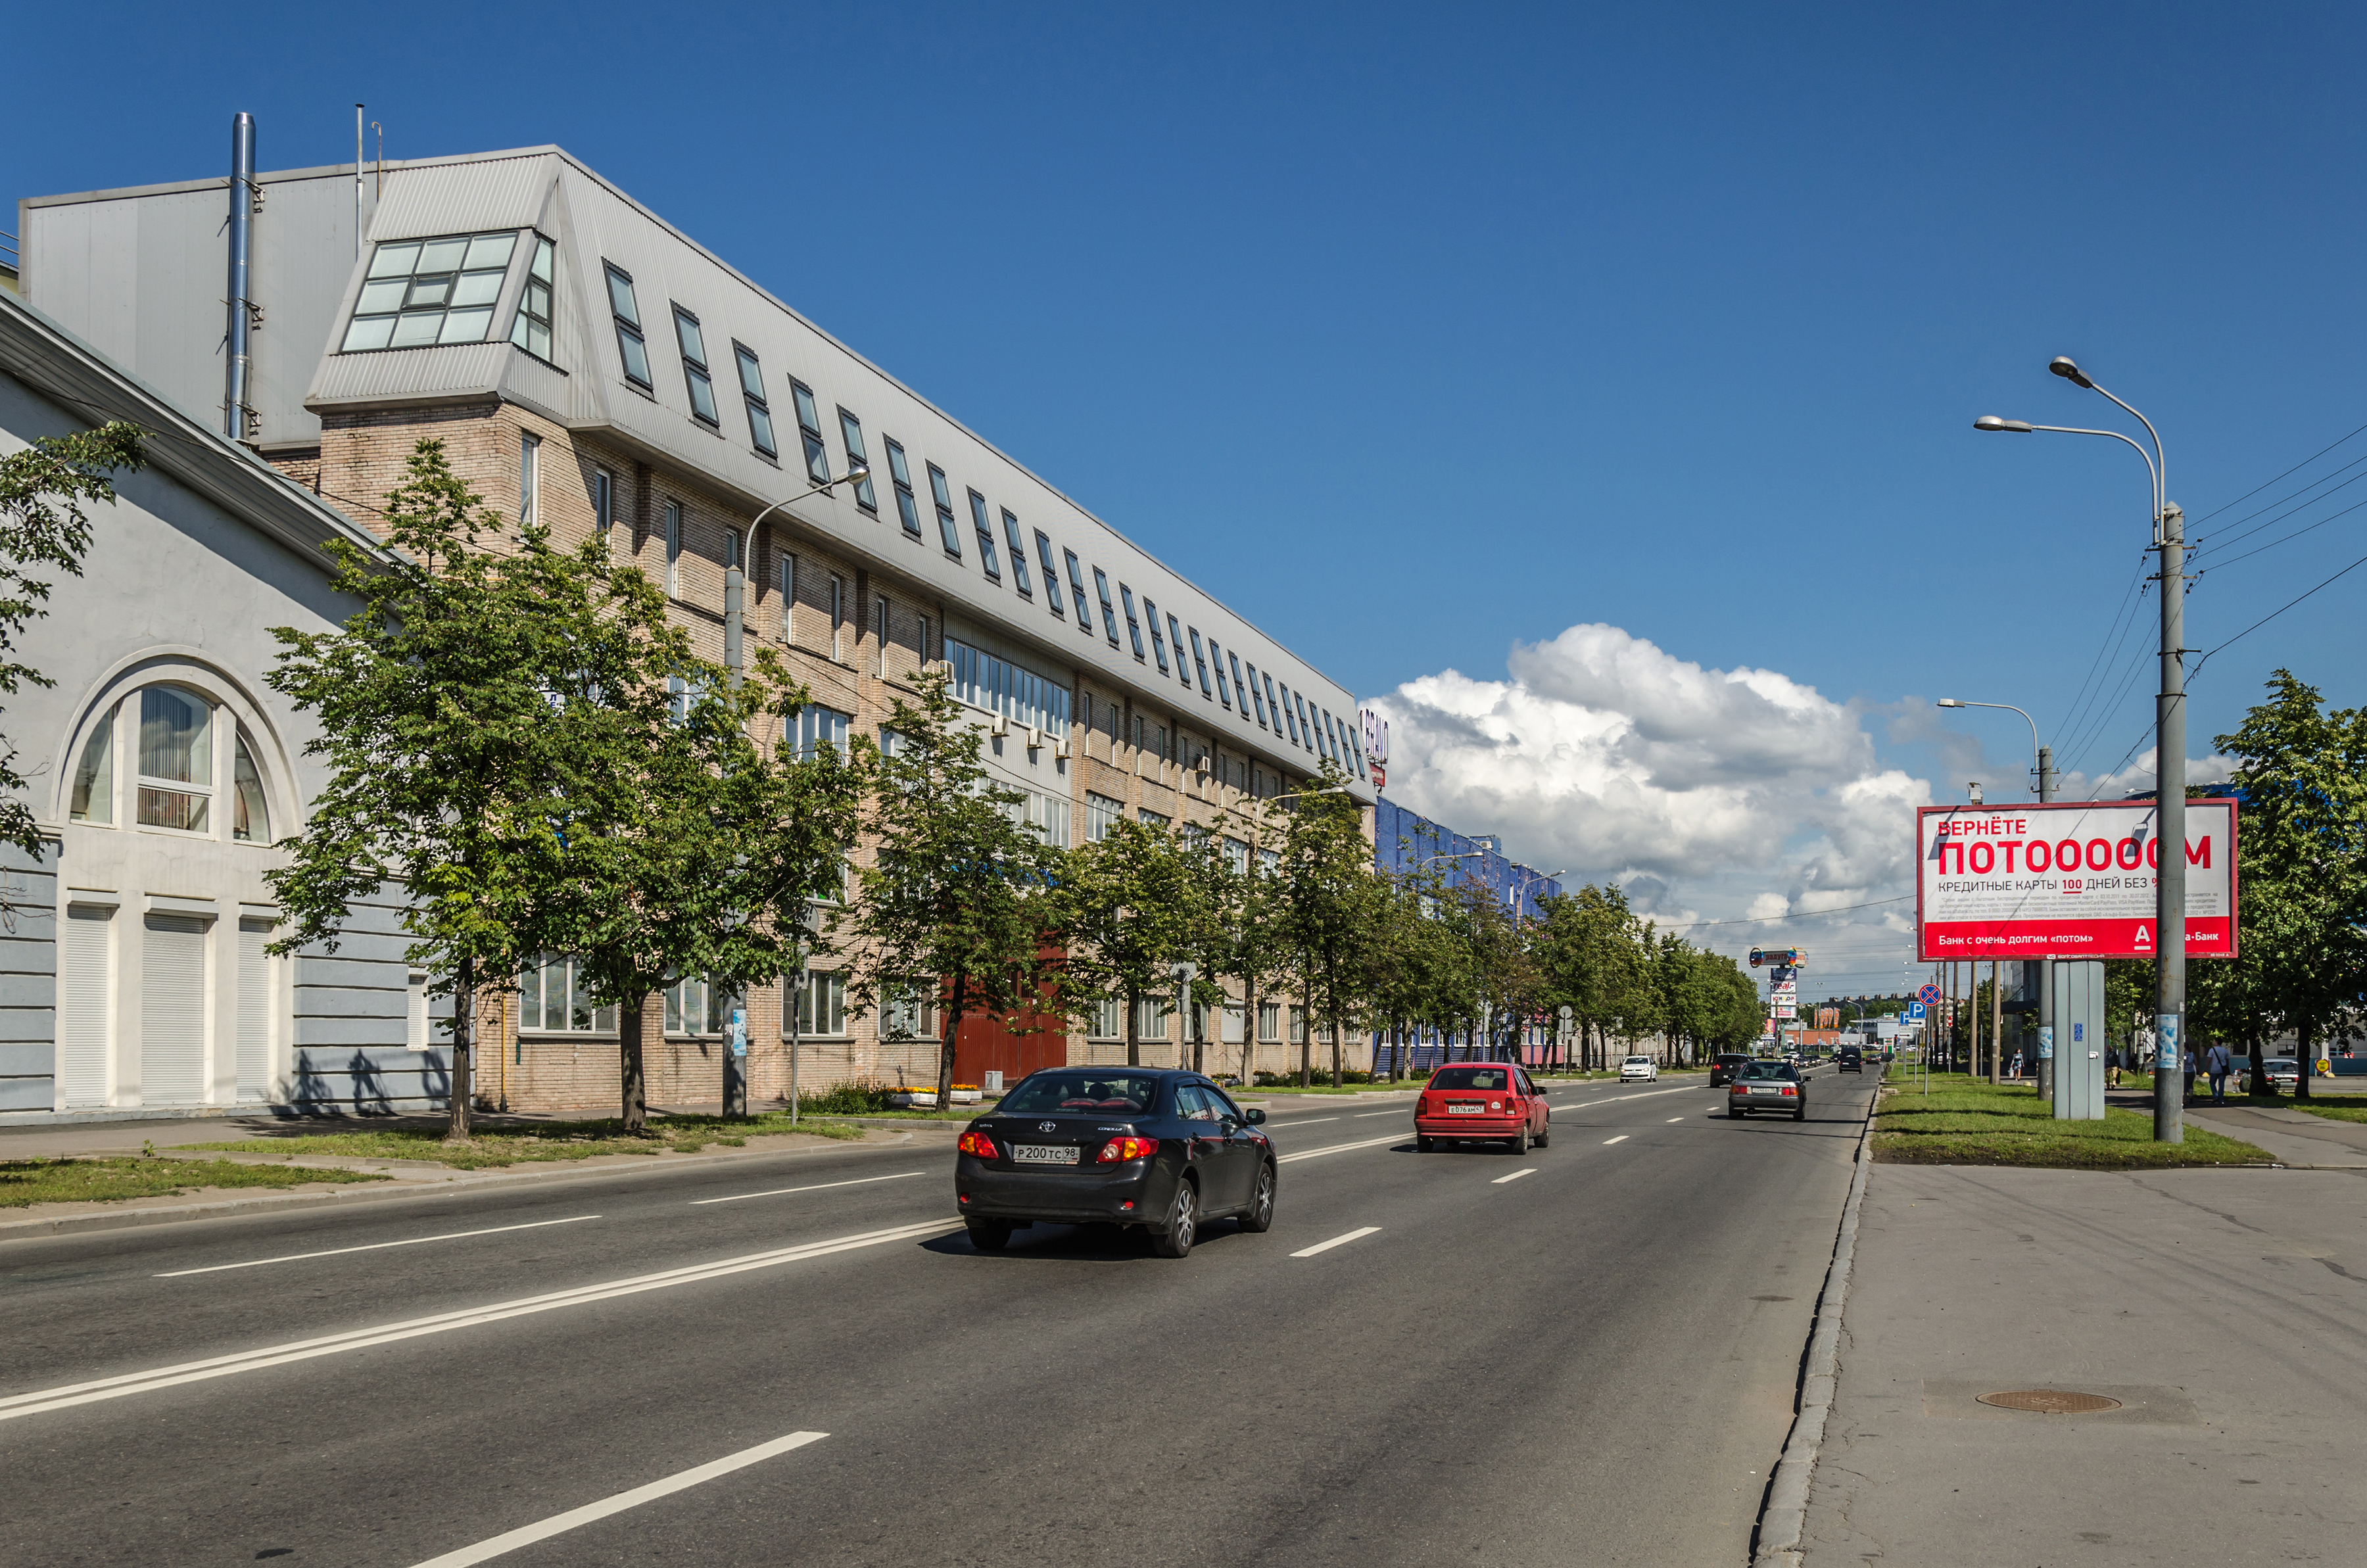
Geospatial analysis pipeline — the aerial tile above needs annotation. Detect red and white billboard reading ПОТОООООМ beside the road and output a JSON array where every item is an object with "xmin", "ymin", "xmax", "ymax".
[{"xmin": 1915, "ymin": 801, "xmax": 2237, "ymax": 962}]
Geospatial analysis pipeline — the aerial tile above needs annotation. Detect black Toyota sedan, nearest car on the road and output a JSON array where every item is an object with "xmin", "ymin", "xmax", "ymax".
[{"xmin": 954, "ymin": 1068, "xmax": 1276, "ymax": 1258}]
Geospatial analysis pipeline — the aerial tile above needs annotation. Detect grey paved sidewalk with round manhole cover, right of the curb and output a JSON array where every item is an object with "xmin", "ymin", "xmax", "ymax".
[{"xmin": 1799, "ymin": 1160, "xmax": 2367, "ymax": 1568}]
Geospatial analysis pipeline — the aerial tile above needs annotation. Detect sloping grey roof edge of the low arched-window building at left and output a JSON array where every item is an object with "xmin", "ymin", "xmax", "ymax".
[{"xmin": 0, "ymin": 289, "xmax": 400, "ymax": 573}]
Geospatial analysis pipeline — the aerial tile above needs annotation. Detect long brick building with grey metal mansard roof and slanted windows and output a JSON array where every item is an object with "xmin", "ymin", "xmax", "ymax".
[{"xmin": 19, "ymin": 135, "xmax": 1377, "ymax": 1108}]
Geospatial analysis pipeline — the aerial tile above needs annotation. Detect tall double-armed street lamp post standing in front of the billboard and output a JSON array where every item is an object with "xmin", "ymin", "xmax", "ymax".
[{"xmin": 1972, "ymin": 355, "xmax": 2187, "ymax": 1144}]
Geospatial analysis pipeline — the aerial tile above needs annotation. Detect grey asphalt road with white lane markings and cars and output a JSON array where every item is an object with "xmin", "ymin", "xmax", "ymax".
[{"xmin": 0, "ymin": 1068, "xmax": 1873, "ymax": 1568}]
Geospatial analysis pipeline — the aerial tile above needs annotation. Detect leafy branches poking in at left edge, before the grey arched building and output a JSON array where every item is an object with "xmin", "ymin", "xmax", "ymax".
[{"xmin": 0, "ymin": 419, "xmax": 147, "ymax": 867}]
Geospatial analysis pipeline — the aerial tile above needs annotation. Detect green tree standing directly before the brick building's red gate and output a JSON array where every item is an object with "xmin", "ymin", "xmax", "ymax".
[{"xmin": 836, "ymin": 668, "xmax": 1061, "ymax": 1106}]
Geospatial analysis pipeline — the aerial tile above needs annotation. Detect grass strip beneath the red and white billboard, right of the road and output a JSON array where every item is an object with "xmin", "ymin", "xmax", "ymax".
[{"xmin": 1875, "ymin": 1073, "xmax": 2275, "ymax": 1170}]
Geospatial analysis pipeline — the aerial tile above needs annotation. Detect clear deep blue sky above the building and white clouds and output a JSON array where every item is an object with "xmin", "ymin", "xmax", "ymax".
[{"xmin": 0, "ymin": 5, "xmax": 2367, "ymax": 989}]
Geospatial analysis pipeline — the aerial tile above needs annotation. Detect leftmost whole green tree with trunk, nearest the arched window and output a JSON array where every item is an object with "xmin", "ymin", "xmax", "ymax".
[{"xmin": 268, "ymin": 440, "xmax": 634, "ymax": 1139}]
